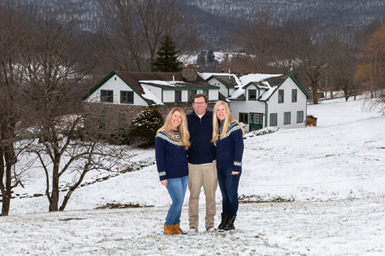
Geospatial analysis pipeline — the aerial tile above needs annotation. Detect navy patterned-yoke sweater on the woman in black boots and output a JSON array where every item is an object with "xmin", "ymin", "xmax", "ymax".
[{"xmin": 217, "ymin": 121, "xmax": 244, "ymax": 172}]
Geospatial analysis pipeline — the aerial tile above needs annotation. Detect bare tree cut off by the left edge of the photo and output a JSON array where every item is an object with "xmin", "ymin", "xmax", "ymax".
[{"xmin": 0, "ymin": 4, "xmax": 34, "ymax": 216}]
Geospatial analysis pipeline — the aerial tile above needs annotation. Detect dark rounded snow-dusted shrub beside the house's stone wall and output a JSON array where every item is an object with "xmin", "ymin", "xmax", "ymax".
[{"xmin": 128, "ymin": 108, "xmax": 163, "ymax": 147}]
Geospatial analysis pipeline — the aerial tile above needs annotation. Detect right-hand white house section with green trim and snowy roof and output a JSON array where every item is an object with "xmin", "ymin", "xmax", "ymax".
[{"xmin": 199, "ymin": 73, "xmax": 309, "ymax": 131}]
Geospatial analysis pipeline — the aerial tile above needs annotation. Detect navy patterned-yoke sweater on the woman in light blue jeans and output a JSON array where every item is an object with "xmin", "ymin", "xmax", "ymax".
[{"xmin": 155, "ymin": 131, "xmax": 188, "ymax": 180}]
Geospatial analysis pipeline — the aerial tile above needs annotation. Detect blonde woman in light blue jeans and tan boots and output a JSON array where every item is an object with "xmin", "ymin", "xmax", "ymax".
[{"xmin": 155, "ymin": 107, "xmax": 190, "ymax": 235}]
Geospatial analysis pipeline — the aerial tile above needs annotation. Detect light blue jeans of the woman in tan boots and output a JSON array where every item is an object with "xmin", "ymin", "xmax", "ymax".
[{"xmin": 165, "ymin": 176, "xmax": 188, "ymax": 225}]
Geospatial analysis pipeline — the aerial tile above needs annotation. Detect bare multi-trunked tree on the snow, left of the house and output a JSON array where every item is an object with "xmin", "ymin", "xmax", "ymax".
[{"xmin": 16, "ymin": 12, "xmax": 126, "ymax": 211}]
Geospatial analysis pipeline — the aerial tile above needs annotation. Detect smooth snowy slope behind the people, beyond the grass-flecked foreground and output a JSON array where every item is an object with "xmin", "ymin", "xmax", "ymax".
[{"xmin": 10, "ymin": 96, "xmax": 385, "ymax": 215}]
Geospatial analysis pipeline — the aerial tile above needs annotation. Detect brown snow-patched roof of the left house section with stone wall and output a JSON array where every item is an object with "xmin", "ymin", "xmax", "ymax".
[{"xmin": 83, "ymin": 71, "xmax": 218, "ymax": 105}]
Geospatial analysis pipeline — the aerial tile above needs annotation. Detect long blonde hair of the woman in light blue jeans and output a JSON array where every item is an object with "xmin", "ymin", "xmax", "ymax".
[{"xmin": 156, "ymin": 107, "xmax": 190, "ymax": 149}]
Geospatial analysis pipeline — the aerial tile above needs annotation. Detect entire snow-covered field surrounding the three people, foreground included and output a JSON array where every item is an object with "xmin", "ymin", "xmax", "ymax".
[{"xmin": 0, "ymin": 95, "xmax": 385, "ymax": 255}]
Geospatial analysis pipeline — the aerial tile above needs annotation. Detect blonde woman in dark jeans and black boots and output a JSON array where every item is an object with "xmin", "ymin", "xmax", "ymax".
[{"xmin": 211, "ymin": 101, "xmax": 244, "ymax": 231}]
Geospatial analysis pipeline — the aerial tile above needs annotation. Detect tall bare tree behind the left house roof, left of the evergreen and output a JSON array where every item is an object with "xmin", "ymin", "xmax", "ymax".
[{"xmin": 99, "ymin": 0, "xmax": 195, "ymax": 71}]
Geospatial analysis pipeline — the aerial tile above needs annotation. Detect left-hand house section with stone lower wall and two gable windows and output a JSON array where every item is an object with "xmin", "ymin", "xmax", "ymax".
[{"xmin": 83, "ymin": 69, "xmax": 219, "ymax": 137}]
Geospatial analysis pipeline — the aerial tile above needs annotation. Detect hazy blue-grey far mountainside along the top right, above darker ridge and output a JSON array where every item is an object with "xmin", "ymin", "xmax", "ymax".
[{"xmin": 187, "ymin": 0, "xmax": 385, "ymax": 27}]
